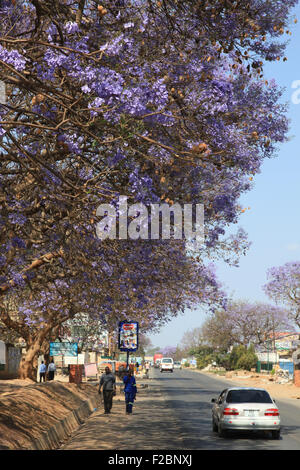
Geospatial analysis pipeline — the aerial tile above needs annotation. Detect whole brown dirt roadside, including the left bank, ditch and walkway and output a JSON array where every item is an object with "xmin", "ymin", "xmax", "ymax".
[{"xmin": 0, "ymin": 376, "xmax": 183, "ymax": 450}]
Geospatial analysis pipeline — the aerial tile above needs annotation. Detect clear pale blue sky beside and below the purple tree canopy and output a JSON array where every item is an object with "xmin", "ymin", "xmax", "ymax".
[{"xmin": 150, "ymin": 6, "xmax": 300, "ymax": 347}]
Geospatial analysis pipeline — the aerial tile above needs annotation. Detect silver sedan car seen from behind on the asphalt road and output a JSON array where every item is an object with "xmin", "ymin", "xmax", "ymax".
[{"xmin": 211, "ymin": 387, "xmax": 280, "ymax": 439}]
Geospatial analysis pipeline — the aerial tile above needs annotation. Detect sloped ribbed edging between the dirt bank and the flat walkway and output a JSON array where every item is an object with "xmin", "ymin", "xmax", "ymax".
[{"xmin": 29, "ymin": 396, "xmax": 100, "ymax": 450}]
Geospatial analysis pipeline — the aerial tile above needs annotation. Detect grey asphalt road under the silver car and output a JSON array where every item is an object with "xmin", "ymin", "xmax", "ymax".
[{"xmin": 151, "ymin": 369, "xmax": 300, "ymax": 450}]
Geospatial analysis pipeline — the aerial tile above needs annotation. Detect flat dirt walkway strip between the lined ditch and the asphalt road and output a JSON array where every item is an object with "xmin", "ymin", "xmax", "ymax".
[{"xmin": 61, "ymin": 379, "xmax": 184, "ymax": 450}]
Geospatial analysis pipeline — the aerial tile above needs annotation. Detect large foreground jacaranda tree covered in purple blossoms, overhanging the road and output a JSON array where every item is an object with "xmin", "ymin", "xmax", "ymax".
[{"xmin": 0, "ymin": 0, "xmax": 296, "ymax": 375}]
